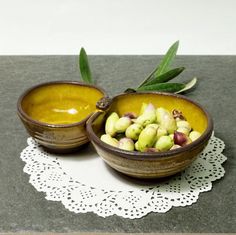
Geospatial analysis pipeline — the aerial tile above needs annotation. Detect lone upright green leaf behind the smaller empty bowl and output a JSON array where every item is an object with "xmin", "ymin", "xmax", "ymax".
[{"xmin": 79, "ymin": 47, "xmax": 94, "ymax": 84}]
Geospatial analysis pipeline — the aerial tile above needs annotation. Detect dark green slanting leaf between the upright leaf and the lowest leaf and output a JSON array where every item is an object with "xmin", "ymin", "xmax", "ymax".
[{"xmin": 145, "ymin": 67, "xmax": 185, "ymax": 86}]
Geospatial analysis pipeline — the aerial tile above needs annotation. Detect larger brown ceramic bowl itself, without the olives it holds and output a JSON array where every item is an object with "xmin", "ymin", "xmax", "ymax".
[{"xmin": 87, "ymin": 92, "xmax": 213, "ymax": 178}]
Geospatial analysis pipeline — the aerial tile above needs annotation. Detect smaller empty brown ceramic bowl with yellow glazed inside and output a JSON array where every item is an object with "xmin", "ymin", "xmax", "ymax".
[{"xmin": 17, "ymin": 81, "xmax": 105, "ymax": 152}]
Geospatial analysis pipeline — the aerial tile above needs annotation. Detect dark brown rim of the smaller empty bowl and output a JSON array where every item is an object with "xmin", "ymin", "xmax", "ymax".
[{"xmin": 17, "ymin": 80, "xmax": 107, "ymax": 128}]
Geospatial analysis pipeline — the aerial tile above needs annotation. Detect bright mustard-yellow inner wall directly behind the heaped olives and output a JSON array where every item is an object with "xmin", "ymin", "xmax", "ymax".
[{"xmin": 110, "ymin": 94, "xmax": 207, "ymax": 133}]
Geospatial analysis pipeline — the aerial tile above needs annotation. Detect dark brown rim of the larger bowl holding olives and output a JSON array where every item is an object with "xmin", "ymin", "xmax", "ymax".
[{"xmin": 86, "ymin": 91, "xmax": 213, "ymax": 161}]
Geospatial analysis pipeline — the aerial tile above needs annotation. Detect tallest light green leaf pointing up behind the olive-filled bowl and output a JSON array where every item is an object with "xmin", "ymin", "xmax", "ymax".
[{"xmin": 155, "ymin": 41, "xmax": 179, "ymax": 77}]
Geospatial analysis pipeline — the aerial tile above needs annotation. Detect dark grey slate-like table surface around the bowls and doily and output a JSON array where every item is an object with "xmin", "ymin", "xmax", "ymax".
[{"xmin": 0, "ymin": 55, "xmax": 236, "ymax": 233}]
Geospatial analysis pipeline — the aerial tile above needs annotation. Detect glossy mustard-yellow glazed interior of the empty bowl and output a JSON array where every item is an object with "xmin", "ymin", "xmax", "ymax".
[{"xmin": 21, "ymin": 83, "xmax": 104, "ymax": 125}]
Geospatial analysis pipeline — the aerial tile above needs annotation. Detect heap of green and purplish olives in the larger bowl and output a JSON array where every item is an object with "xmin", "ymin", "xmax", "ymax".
[{"xmin": 101, "ymin": 103, "xmax": 201, "ymax": 152}]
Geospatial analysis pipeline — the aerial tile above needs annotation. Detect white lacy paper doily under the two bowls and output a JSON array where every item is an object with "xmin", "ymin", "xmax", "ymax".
[{"xmin": 21, "ymin": 135, "xmax": 227, "ymax": 219}]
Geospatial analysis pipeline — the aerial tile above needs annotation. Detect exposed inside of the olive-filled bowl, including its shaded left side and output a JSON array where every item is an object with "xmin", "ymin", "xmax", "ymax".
[{"xmin": 92, "ymin": 93, "xmax": 209, "ymax": 143}]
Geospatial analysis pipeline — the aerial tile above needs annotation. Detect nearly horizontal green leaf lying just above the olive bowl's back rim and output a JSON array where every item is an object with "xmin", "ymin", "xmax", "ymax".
[{"xmin": 137, "ymin": 83, "xmax": 185, "ymax": 93}]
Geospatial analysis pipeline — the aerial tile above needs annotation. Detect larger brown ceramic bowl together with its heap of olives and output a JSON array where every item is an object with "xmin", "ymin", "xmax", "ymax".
[{"xmin": 86, "ymin": 92, "xmax": 213, "ymax": 178}]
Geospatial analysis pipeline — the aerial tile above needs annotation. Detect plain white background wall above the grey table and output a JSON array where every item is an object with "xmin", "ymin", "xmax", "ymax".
[{"xmin": 0, "ymin": 0, "xmax": 236, "ymax": 55}]
